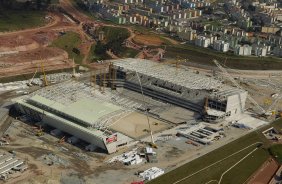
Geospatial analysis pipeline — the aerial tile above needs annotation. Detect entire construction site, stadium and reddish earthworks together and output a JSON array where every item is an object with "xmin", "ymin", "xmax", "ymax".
[{"xmin": 0, "ymin": 0, "xmax": 282, "ymax": 184}]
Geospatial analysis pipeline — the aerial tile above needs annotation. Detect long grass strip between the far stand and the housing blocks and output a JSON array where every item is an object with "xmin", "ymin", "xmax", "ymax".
[{"xmin": 165, "ymin": 45, "xmax": 282, "ymax": 70}]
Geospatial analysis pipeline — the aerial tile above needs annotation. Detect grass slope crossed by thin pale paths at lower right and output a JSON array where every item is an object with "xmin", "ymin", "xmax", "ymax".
[{"xmin": 149, "ymin": 120, "xmax": 282, "ymax": 184}]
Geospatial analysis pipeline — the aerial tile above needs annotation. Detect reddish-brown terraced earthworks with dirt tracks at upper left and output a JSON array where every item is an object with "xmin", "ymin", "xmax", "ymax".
[{"xmin": 0, "ymin": 1, "xmax": 97, "ymax": 77}]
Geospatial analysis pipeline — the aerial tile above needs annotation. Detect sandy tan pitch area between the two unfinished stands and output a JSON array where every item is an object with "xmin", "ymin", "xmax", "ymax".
[{"xmin": 110, "ymin": 112, "xmax": 168, "ymax": 138}]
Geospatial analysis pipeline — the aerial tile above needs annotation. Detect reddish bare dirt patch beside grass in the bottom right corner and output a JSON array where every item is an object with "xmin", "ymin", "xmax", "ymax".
[{"xmin": 248, "ymin": 158, "xmax": 279, "ymax": 184}]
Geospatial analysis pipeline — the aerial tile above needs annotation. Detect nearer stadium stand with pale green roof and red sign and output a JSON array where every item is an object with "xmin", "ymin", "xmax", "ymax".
[{"xmin": 14, "ymin": 83, "xmax": 131, "ymax": 153}]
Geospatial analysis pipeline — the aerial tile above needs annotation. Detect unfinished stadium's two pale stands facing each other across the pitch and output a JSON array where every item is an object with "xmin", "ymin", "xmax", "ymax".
[{"xmin": 14, "ymin": 59, "xmax": 250, "ymax": 153}]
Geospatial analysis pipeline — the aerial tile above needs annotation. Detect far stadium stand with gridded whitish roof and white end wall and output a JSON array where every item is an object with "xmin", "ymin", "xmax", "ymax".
[{"xmin": 113, "ymin": 59, "xmax": 247, "ymax": 122}]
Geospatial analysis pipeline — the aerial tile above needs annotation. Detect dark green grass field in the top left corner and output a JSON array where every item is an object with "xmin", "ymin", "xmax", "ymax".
[{"xmin": 0, "ymin": 10, "xmax": 46, "ymax": 32}]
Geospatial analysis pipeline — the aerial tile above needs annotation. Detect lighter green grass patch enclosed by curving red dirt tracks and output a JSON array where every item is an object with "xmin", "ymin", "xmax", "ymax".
[{"xmin": 50, "ymin": 32, "xmax": 83, "ymax": 64}]
